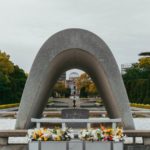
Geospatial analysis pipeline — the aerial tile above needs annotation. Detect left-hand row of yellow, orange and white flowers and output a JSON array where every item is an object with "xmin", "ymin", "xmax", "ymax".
[{"xmin": 28, "ymin": 128, "xmax": 73, "ymax": 141}]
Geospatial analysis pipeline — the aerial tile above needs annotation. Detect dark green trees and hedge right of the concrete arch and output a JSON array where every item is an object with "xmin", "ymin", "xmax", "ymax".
[{"xmin": 123, "ymin": 55, "xmax": 150, "ymax": 104}]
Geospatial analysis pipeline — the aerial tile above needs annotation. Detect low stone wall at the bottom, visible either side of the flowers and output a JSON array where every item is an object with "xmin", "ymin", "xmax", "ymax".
[{"xmin": 0, "ymin": 130, "xmax": 150, "ymax": 150}]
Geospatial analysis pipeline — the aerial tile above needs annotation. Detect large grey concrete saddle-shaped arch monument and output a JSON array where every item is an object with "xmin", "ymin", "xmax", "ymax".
[{"xmin": 16, "ymin": 29, "xmax": 134, "ymax": 129}]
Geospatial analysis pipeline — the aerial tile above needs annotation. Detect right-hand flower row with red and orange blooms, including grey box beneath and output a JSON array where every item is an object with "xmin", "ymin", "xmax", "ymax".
[{"xmin": 79, "ymin": 127, "xmax": 124, "ymax": 150}]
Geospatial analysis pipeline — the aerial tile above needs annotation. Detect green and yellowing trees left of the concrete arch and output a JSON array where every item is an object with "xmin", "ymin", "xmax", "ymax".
[{"xmin": 0, "ymin": 51, "xmax": 27, "ymax": 104}]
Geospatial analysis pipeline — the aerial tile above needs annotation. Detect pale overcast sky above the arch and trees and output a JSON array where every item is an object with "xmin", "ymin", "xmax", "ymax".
[{"xmin": 0, "ymin": 0, "xmax": 150, "ymax": 77}]
